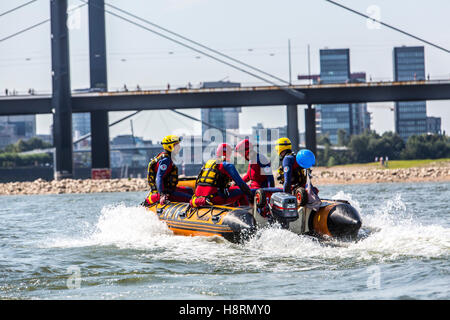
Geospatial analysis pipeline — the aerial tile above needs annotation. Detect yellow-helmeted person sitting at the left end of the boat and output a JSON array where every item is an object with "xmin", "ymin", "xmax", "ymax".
[{"xmin": 144, "ymin": 135, "xmax": 193, "ymax": 206}]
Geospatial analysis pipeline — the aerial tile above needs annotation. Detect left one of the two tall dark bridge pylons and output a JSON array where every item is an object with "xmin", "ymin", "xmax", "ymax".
[{"xmin": 50, "ymin": 0, "xmax": 73, "ymax": 180}]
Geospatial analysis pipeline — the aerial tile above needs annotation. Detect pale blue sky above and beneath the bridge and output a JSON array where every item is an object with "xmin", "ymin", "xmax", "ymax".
[{"xmin": 0, "ymin": 0, "xmax": 450, "ymax": 140}]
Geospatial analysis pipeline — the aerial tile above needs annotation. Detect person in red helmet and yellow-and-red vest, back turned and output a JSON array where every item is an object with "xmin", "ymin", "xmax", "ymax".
[{"xmin": 190, "ymin": 143, "xmax": 253, "ymax": 207}]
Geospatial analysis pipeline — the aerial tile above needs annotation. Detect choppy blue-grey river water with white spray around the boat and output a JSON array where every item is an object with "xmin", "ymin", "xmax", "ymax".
[{"xmin": 0, "ymin": 183, "xmax": 450, "ymax": 300}]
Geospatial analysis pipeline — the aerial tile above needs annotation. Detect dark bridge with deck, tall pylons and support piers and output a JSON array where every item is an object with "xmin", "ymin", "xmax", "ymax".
[{"xmin": 0, "ymin": 0, "xmax": 450, "ymax": 179}]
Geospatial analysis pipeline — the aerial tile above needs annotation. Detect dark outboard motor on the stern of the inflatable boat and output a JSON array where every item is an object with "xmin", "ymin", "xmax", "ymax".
[{"xmin": 270, "ymin": 192, "xmax": 298, "ymax": 229}]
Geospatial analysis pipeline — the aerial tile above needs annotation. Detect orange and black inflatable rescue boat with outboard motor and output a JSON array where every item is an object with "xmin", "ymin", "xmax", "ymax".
[{"xmin": 147, "ymin": 178, "xmax": 361, "ymax": 243}]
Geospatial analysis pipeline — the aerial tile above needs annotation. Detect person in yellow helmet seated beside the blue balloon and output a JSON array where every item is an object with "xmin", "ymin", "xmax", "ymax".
[{"xmin": 275, "ymin": 138, "xmax": 307, "ymax": 193}]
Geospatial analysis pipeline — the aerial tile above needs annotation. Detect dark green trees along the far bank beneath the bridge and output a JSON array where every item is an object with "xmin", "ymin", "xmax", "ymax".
[{"xmin": 0, "ymin": 130, "xmax": 450, "ymax": 171}]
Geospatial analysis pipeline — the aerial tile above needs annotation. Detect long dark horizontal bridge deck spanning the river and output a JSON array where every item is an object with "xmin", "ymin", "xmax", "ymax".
[{"xmin": 0, "ymin": 80, "xmax": 450, "ymax": 115}]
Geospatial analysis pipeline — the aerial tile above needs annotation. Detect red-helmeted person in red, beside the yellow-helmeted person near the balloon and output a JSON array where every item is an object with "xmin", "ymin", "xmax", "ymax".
[{"xmin": 236, "ymin": 139, "xmax": 275, "ymax": 189}]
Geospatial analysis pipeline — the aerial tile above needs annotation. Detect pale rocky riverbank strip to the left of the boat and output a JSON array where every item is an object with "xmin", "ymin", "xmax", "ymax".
[{"xmin": 0, "ymin": 178, "xmax": 148, "ymax": 195}]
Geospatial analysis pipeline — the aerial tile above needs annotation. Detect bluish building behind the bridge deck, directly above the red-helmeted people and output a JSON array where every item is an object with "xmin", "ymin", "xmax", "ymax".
[{"xmin": 201, "ymin": 81, "xmax": 241, "ymax": 135}]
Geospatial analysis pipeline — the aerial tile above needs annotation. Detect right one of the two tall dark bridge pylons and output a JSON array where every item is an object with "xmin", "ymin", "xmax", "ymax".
[{"xmin": 89, "ymin": 0, "xmax": 110, "ymax": 178}]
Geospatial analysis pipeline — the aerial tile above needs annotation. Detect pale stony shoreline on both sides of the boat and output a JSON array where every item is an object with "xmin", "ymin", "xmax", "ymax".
[{"xmin": 0, "ymin": 166, "xmax": 450, "ymax": 195}]
